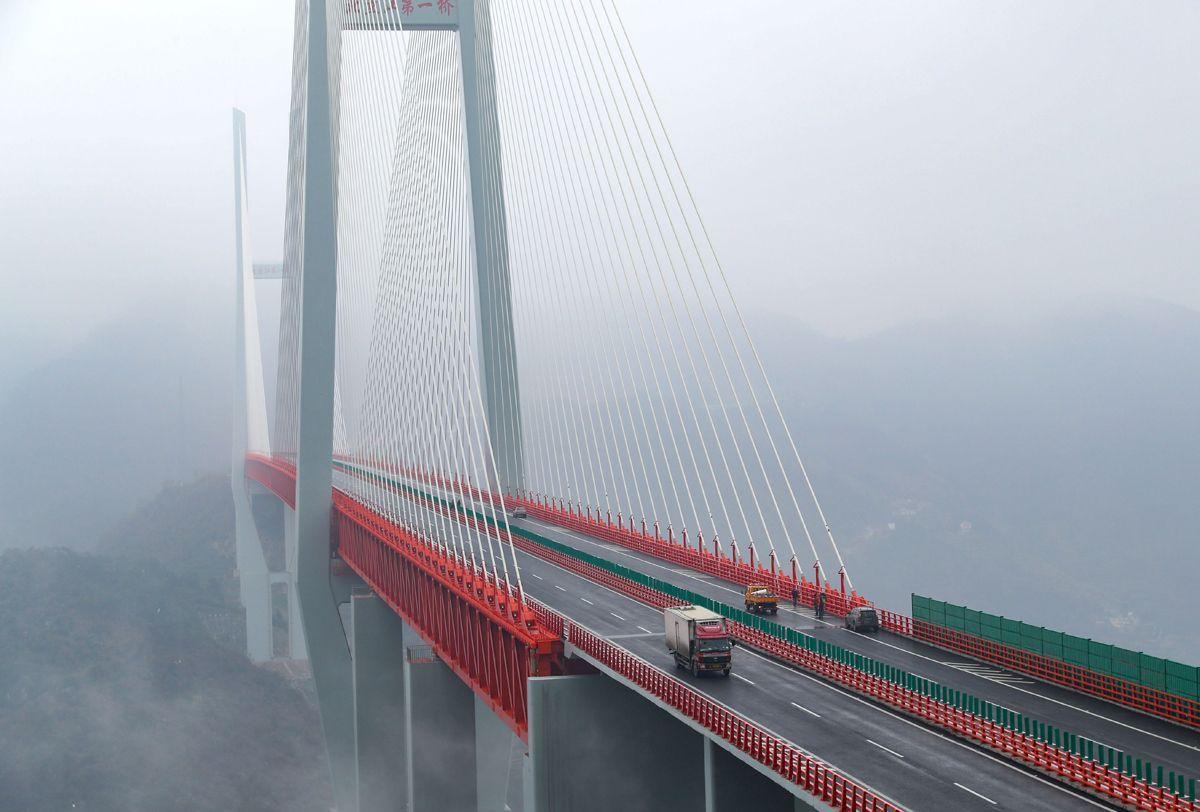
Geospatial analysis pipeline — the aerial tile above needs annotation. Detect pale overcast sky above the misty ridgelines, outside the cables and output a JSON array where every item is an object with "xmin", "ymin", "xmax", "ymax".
[{"xmin": 0, "ymin": 0, "xmax": 1200, "ymax": 362}]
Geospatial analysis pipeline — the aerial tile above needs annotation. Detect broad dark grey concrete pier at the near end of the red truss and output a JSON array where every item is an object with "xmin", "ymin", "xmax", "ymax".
[{"xmin": 524, "ymin": 674, "xmax": 706, "ymax": 812}]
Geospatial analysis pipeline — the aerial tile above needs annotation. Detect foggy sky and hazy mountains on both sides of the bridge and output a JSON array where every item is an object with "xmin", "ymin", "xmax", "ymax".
[{"xmin": 0, "ymin": 0, "xmax": 1200, "ymax": 661}]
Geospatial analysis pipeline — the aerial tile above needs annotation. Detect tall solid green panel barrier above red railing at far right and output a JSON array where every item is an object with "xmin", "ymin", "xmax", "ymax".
[{"xmin": 912, "ymin": 593, "xmax": 1200, "ymax": 700}]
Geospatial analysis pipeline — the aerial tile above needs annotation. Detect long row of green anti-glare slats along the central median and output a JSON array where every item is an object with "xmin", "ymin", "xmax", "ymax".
[{"xmin": 335, "ymin": 462, "xmax": 1196, "ymax": 801}]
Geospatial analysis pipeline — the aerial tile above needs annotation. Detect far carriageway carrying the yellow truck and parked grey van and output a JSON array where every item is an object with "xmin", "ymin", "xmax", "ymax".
[{"xmin": 514, "ymin": 519, "xmax": 1200, "ymax": 778}]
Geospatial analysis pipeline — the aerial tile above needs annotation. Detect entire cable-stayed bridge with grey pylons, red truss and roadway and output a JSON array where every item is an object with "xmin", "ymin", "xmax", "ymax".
[{"xmin": 233, "ymin": 0, "xmax": 1200, "ymax": 811}]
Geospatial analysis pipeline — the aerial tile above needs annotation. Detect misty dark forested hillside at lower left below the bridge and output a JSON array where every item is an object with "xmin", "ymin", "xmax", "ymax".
[{"xmin": 0, "ymin": 477, "xmax": 330, "ymax": 811}]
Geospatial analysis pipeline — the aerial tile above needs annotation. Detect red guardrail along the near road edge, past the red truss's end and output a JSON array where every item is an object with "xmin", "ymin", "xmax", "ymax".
[{"xmin": 566, "ymin": 621, "xmax": 902, "ymax": 812}]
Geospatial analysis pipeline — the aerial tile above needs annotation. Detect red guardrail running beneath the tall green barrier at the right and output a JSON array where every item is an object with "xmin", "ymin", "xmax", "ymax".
[{"xmin": 902, "ymin": 612, "xmax": 1200, "ymax": 729}]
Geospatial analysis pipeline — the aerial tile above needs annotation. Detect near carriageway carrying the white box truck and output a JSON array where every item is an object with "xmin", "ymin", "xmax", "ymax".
[{"xmin": 517, "ymin": 534, "xmax": 1106, "ymax": 811}]
